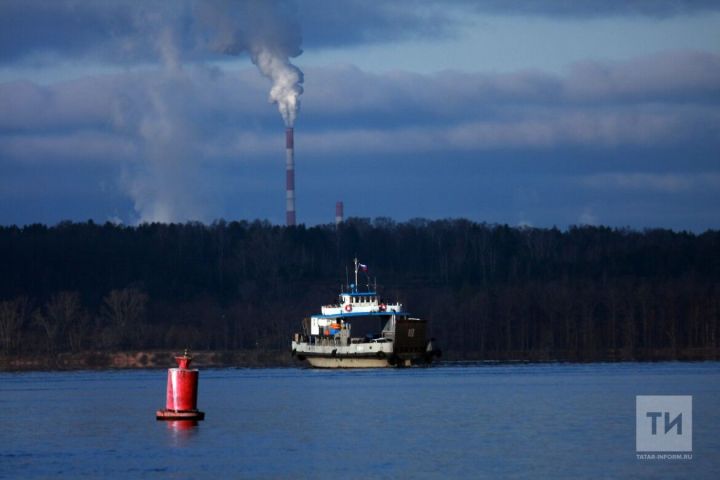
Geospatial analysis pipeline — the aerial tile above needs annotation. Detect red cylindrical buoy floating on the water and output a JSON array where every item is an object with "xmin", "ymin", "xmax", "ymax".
[{"xmin": 155, "ymin": 350, "xmax": 205, "ymax": 420}]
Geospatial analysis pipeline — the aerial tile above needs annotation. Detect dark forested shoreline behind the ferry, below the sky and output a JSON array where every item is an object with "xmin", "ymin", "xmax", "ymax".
[{"xmin": 0, "ymin": 218, "xmax": 720, "ymax": 361}]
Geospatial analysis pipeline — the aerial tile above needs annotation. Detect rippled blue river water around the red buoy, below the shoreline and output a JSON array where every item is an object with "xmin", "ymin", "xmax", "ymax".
[{"xmin": 0, "ymin": 362, "xmax": 720, "ymax": 479}]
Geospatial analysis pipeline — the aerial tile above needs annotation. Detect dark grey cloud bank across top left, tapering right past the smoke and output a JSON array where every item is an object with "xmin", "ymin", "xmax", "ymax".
[{"xmin": 0, "ymin": 0, "xmax": 455, "ymax": 63}]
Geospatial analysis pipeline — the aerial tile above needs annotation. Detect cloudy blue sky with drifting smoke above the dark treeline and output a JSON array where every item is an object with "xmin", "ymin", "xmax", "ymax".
[{"xmin": 0, "ymin": 0, "xmax": 720, "ymax": 233}]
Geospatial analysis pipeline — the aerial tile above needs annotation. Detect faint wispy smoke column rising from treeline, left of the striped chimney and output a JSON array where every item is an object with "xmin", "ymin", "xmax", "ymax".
[{"xmin": 113, "ymin": 5, "xmax": 210, "ymax": 222}]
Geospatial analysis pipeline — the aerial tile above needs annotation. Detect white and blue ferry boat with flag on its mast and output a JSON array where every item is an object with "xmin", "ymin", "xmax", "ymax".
[{"xmin": 292, "ymin": 258, "xmax": 441, "ymax": 368}]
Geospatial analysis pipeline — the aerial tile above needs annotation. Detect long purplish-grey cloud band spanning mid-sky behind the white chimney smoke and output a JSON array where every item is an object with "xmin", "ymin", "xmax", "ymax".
[{"xmin": 0, "ymin": 50, "xmax": 720, "ymax": 161}]
